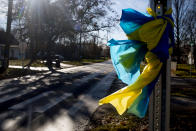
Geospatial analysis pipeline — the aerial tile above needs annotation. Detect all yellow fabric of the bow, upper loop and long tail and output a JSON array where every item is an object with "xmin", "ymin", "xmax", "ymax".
[{"xmin": 99, "ymin": 9, "xmax": 172, "ymax": 115}]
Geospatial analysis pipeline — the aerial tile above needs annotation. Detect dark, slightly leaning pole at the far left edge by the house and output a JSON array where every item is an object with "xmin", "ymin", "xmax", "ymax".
[{"xmin": 0, "ymin": 0, "xmax": 13, "ymax": 73}]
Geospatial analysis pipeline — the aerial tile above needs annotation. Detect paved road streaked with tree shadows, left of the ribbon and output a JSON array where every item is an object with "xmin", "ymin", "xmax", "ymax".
[{"xmin": 0, "ymin": 61, "xmax": 115, "ymax": 131}]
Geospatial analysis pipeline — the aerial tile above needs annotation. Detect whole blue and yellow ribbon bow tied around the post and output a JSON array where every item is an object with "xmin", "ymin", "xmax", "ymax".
[{"xmin": 99, "ymin": 8, "xmax": 174, "ymax": 118}]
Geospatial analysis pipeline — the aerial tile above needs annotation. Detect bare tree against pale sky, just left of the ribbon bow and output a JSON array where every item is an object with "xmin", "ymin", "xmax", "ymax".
[{"xmin": 64, "ymin": 0, "xmax": 118, "ymax": 58}]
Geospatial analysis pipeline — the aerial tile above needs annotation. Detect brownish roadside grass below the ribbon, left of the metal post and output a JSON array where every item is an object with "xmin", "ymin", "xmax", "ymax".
[{"xmin": 85, "ymin": 105, "xmax": 148, "ymax": 131}]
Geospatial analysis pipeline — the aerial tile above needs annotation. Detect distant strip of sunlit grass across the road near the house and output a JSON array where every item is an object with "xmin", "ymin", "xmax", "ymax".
[{"xmin": 9, "ymin": 59, "xmax": 46, "ymax": 67}]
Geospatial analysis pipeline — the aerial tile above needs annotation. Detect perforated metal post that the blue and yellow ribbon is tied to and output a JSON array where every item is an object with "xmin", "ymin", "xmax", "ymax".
[{"xmin": 149, "ymin": 0, "xmax": 171, "ymax": 131}]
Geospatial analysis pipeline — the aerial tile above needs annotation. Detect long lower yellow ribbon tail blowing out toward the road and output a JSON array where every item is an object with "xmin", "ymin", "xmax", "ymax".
[{"xmin": 99, "ymin": 52, "xmax": 162, "ymax": 115}]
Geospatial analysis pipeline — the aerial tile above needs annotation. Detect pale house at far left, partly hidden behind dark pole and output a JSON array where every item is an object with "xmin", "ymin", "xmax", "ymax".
[{"xmin": 0, "ymin": 30, "xmax": 20, "ymax": 59}]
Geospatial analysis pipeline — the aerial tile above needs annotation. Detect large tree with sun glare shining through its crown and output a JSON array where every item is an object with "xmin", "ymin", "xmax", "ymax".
[{"xmin": 11, "ymin": 0, "xmax": 74, "ymax": 69}]
